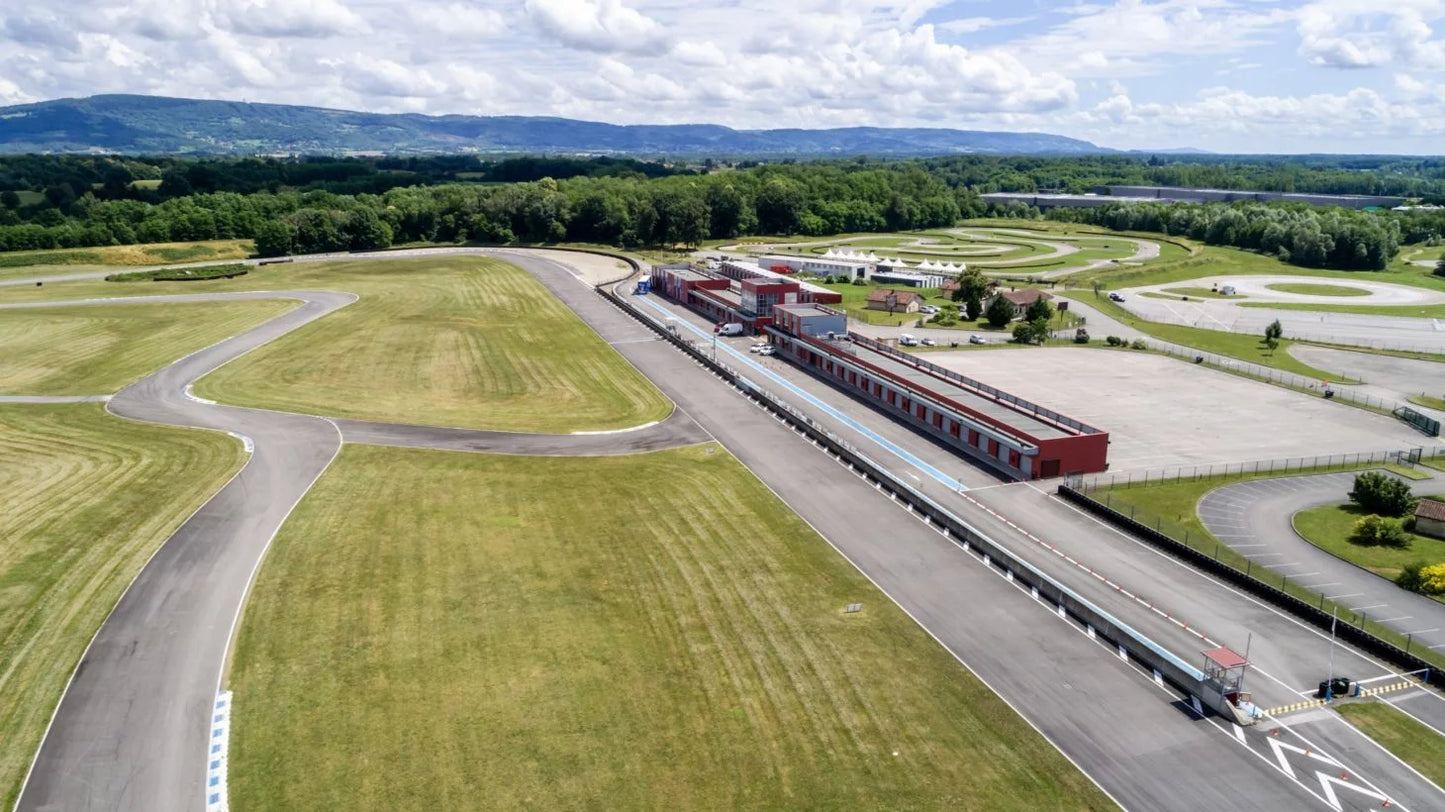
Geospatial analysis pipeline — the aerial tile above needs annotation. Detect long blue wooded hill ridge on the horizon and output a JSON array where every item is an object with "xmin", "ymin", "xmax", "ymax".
[{"xmin": 0, "ymin": 95, "xmax": 1113, "ymax": 157}]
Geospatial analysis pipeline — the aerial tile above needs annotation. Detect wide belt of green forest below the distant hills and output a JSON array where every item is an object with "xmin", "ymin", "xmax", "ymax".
[{"xmin": 0, "ymin": 148, "xmax": 1445, "ymax": 269}]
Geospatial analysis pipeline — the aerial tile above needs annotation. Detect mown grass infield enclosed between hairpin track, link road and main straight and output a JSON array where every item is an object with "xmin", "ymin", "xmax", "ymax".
[{"xmin": 192, "ymin": 257, "xmax": 672, "ymax": 433}]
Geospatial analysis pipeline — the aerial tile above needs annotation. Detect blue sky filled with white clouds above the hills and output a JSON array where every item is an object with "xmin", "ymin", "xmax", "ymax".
[{"xmin": 0, "ymin": 0, "xmax": 1445, "ymax": 153}]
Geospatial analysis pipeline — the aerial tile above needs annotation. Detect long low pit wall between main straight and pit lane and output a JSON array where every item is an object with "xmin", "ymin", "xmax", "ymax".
[{"xmin": 597, "ymin": 285, "xmax": 1207, "ymax": 701}]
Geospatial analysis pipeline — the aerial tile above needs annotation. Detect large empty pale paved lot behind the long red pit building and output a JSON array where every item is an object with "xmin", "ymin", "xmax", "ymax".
[{"xmin": 928, "ymin": 347, "xmax": 1436, "ymax": 472}]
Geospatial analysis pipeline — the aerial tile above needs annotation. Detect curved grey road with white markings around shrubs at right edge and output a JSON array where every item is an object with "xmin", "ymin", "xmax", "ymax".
[{"xmin": 1199, "ymin": 474, "xmax": 1445, "ymax": 653}]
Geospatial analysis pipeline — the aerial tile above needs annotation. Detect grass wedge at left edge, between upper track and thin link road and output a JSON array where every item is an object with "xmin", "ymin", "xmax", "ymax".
[{"xmin": 0, "ymin": 300, "xmax": 296, "ymax": 394}]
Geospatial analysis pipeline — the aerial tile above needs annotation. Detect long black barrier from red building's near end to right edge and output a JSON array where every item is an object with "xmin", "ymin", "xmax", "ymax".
[{"xmin": 1058, "ymin": 484, "xmax": 1445, "ymax": 688}]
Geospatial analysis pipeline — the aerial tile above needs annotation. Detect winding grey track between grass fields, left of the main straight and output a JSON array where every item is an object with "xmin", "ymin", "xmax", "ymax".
[{"xmin": 8, "ymin": 268, "xmax": 708, "ymax": 811}]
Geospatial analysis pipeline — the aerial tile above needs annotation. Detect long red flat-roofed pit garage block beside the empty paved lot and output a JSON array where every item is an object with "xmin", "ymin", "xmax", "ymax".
[{"xmin": 766, "ymin": 303, "xmax": 1108, "ymax": 480}]
